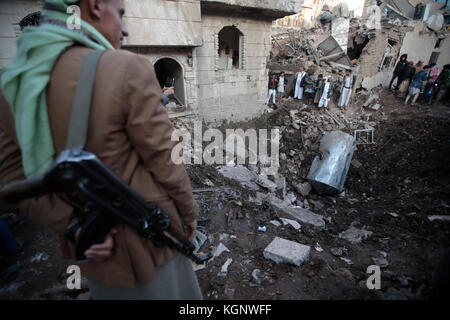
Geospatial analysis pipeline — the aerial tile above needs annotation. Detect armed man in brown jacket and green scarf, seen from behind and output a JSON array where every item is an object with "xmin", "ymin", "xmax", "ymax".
[{"xmin": 0, "ymin": 0, "xmax": 202, "ymax": 300}]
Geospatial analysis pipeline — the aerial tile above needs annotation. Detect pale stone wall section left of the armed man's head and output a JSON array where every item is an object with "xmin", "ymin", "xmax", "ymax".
[{"xmin": 0, "ymin": 0, "xmax": 44, "ymax": 70}]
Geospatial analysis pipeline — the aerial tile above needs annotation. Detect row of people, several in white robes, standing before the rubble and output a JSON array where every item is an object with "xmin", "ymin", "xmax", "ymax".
[{"xmin": 266, "ymin": 66, "xmax": 356, "ymax": 110}]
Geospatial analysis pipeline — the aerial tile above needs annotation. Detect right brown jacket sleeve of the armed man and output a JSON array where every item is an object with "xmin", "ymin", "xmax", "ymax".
[{"xmin": 123, "ymin": 57, "xmax": 198, "ymax": 223}]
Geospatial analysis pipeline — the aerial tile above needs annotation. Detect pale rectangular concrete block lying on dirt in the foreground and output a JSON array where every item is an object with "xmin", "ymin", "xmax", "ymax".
[{"xmin": 263, "ymin": 237, "xmax": 311, "ymax": 266}]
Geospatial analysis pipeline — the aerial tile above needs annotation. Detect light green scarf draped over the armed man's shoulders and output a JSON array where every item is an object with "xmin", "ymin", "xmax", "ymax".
[{"xmin": 1, "ymin": 0, "xmax": 114, "ymax": 177}]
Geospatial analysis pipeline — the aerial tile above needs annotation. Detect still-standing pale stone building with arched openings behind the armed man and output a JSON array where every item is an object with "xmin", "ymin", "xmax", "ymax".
[{"xmin": 0, "ymin": 0, "xmax": 302, "ymax": 122}]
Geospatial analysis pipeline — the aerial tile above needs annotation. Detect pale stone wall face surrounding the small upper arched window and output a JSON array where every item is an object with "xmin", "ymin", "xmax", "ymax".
[{"xmin": 196, "ymin": 15, "xmax": 271, "ymax": 122}]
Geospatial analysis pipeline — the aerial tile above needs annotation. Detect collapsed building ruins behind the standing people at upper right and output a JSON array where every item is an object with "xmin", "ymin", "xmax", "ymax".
[{"xmin": 272, "ymin": 0, "xmax": 450, "ymax": 94}]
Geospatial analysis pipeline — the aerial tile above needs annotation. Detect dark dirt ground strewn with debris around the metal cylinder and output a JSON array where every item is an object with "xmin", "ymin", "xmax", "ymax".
[{"xmin": 0, "ymin": 90, "xmax": 450, "ymax": 300}]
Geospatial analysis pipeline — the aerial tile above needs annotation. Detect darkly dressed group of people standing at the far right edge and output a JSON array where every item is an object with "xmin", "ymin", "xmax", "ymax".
[{"xmin": 389, "ymin": 54, "xmax": 450, "ymax": 106}]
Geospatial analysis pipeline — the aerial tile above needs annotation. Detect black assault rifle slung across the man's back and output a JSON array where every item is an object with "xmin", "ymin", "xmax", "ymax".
[{"xmin": 0, "ymin": 148, "xmax": 211, "ymax": 264}]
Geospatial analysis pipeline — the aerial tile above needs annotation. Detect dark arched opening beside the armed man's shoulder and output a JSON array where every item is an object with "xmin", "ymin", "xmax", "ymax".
[{"xmin": 154, "ymin": 58, "xmax": 185, "ymax": 106}]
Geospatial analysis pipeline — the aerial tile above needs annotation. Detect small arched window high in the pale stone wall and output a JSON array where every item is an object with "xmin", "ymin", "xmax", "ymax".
[{"xmin": 218, "ymin": 26, "xmax": 244, "ymax": 70}]
